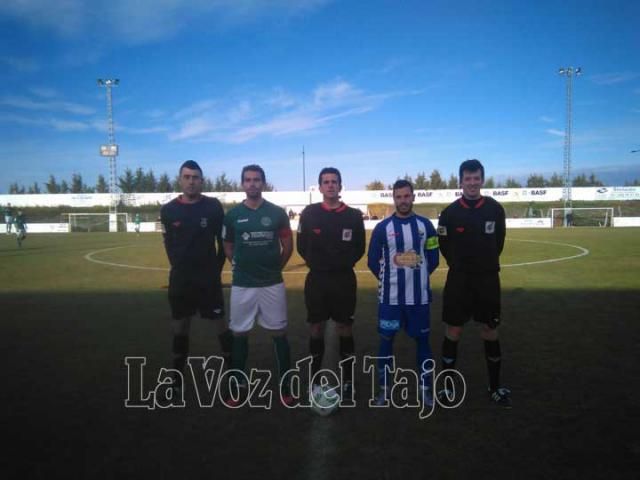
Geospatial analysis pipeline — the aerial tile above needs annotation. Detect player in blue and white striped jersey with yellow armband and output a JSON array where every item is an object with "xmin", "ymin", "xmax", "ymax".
[{"xmin": 368, "ymin": 180, "xmax": 439, "ymax": 406}]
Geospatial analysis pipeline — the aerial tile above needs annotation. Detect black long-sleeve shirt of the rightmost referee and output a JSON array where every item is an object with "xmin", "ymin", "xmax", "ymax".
[{"xmin": 438, "ymin": 197, "xmax": 506, "ymax": 273}]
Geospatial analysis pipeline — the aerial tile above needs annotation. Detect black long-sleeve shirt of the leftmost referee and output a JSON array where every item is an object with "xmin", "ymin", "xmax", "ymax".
[{"xmin": 160, "ymin": 196, "xmax": 225, "ymax": 281}]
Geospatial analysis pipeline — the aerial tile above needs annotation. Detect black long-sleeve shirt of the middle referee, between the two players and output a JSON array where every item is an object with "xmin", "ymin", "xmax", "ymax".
[{"xmin": 296, "ymin": 203, "xmax": 366, "ymax": 272}]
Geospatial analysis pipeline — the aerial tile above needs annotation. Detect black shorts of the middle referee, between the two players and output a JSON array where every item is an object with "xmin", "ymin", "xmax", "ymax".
[{"xmin": 304, "ymin": 270, "xmax": 358, "ymax": 325}]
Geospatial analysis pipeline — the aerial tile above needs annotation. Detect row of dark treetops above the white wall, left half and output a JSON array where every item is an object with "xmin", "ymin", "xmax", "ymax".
[{"xmin": 9, "ymin": 168, "xmax": 274, "ymax": 194}]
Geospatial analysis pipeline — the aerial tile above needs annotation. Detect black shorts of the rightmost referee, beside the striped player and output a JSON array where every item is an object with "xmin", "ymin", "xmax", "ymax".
[{"xmin": 442, "ymin": 270, "xmax": 500, "ymax": 326}]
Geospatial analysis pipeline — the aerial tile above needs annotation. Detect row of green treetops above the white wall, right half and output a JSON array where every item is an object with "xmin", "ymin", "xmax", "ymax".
[{"xmin": 365, "ymin": 169, "xmax": 612, "ymax": 190}]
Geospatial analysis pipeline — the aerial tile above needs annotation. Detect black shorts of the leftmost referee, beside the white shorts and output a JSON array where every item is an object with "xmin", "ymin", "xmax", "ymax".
[{"xmin": 169, "ymin": 271, "xmax": 224, "ymax": 319}]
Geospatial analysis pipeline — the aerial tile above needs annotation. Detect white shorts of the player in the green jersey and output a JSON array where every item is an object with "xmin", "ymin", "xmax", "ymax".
[{"xmin": 229, "ymin": 283, "xmax": 287, "ymax": 333}]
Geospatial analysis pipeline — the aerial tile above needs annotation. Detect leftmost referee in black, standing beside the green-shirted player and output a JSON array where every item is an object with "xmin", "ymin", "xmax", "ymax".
[{"xmin": 160, "ymin": 160, "xmax": 233, "ymax": 395}]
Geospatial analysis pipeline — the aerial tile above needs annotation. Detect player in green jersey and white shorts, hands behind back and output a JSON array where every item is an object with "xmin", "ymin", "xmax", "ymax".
[{"xmin": 222, "ymin": 165, "xmax": 293, "ymax": 406}]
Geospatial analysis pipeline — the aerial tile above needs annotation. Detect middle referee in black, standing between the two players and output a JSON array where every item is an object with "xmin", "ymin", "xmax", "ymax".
[{"xmin": 296, "ymin": 167, "xmax": 365, "ymax": 405}]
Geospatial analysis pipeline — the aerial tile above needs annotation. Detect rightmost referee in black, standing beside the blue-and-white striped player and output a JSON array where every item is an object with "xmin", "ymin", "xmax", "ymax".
[{"xmin": 438, "ymin": 160, "xmax": 511, "ymax": 408}]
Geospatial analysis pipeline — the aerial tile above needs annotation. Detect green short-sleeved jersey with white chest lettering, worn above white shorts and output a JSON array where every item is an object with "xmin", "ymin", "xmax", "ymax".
[{"xmin": 222, "ymin": 200, "xmax": 291, "ymax": 288}]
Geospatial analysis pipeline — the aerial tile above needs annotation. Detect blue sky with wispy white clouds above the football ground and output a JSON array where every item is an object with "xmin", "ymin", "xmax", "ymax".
[{"xmin": 0, "ymin": 0, "xmax": 640, "ymax": 193}]
